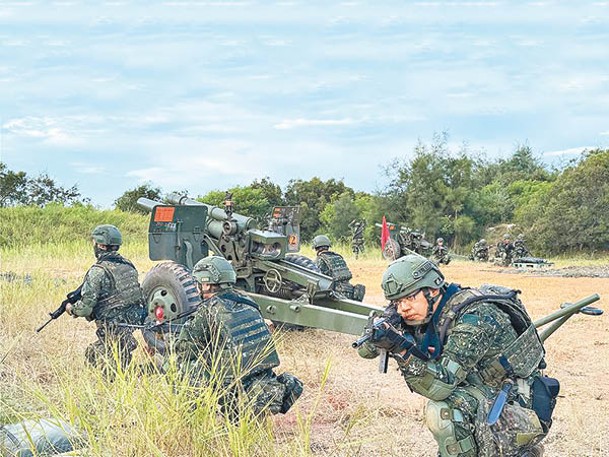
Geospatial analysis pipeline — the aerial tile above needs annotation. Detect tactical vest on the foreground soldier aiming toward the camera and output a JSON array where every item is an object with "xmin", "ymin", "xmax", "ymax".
[{"xmin": 438, "ymin": 284, "xmax": 545, "ymax": 384}]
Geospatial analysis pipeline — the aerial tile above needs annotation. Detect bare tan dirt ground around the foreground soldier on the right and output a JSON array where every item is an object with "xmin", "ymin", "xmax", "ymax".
[{"xmin": 275, "ymin": 260, "xmax": 609, "ymax": 457}]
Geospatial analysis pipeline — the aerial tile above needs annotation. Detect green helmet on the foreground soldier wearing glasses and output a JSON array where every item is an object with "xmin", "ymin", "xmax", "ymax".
[{"xmin": 381, "ymin": 254, "xmax": 444, "ymax": 300}]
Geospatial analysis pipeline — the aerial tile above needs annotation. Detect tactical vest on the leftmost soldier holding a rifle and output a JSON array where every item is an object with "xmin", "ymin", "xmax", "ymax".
[{"xmin": 91, "ymin": 253, "xmax": 144, "ymax": 323}]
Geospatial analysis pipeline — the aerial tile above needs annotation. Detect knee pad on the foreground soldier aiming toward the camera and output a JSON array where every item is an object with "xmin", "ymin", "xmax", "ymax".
[{"xmin": 425, "ymin": 400, "xmax": 477, "ymax": 457}]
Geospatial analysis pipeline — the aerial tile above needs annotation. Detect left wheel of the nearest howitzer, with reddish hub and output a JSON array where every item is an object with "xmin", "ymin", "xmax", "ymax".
[{"xmin": 142, "ymin": 262, "xmax": 201, "ymax": 354}]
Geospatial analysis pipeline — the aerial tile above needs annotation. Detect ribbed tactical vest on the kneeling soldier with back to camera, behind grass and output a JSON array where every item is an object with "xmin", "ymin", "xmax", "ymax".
[{"xmin": 203, "ymin": 291, "xmax": 279, "ymax": 379}]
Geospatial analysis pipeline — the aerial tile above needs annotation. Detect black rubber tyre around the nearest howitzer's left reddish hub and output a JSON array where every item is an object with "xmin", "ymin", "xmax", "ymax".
[{"xmin": 142, "ymin": 262, "xmax": 201, "ymax": 354}]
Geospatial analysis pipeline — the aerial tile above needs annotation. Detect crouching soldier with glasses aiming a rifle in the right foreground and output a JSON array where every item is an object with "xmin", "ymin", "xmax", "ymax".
[{"xmin": 359, "ymin": 255, "xmax": 558, "ymax": 457}]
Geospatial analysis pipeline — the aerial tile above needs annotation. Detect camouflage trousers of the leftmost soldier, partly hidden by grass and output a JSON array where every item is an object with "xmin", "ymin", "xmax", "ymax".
[{"xmin": 85, "ymin": 321, "xmax": 137, "ymax": 374}]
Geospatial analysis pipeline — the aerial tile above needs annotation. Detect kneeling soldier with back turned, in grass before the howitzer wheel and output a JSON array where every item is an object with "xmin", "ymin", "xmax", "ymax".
[{"xmin": 175, "ymin": 256, "xmax": 302, "ymax": 416}]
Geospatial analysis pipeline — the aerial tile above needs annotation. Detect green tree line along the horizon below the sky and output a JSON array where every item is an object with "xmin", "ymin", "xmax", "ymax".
[{"xmin": 0, "ymin": 134, "xmax": 609, "ymax": 255}]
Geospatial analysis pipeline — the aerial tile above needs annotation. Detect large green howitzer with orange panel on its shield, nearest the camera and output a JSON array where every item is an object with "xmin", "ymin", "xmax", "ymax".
[{"xmin": 138, "ymin": 194, "xmax": 379, "ymax": 352}]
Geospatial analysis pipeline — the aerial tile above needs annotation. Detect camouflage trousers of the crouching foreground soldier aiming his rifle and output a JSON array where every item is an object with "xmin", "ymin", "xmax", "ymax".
[{"xmin": 426, "ymin": 387, "xmax": 545, "ymax": 457}]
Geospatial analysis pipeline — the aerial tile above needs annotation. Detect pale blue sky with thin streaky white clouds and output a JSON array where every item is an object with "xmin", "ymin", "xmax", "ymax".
[{"xmin": 0, "ymin": 0, "xmax": 609, "ymax": 208}]
